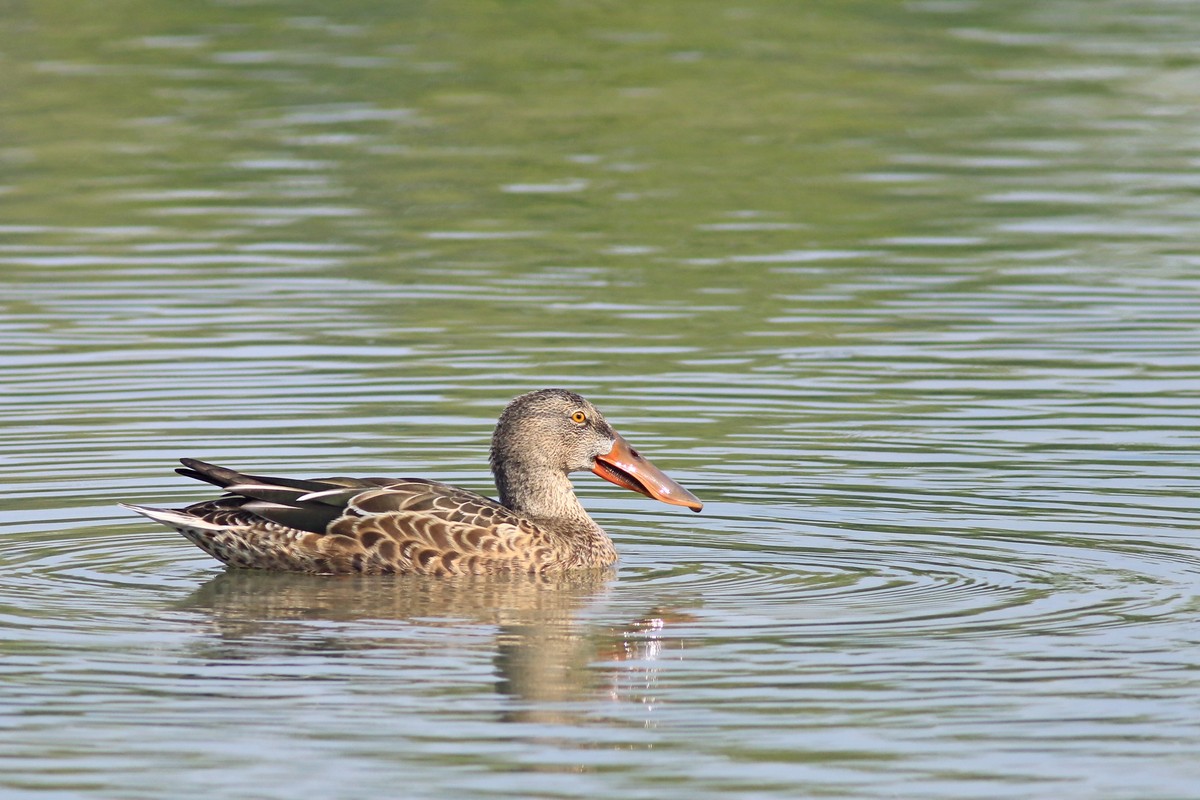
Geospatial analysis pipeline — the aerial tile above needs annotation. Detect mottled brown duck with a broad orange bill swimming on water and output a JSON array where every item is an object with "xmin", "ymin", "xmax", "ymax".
[{"xmin": 120, "ymin": 389, "xmax": 703, "ymax": 575}]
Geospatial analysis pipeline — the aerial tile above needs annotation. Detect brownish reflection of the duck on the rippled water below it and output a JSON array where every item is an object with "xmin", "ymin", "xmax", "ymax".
[{"xmin": 178, "ymin": 569, "xmax": 688, "ymax": 722}]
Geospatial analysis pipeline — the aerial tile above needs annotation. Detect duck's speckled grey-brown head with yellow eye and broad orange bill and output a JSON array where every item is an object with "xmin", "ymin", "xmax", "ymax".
[{"xmin": 491, "ymin": 389, "xmax": 703, "ymax": 511}]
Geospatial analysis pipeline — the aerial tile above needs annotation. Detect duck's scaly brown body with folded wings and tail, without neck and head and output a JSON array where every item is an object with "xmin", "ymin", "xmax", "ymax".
[{"xmin": 124, "ymin": 459, "xmax": 600, "ymax": 575}]
